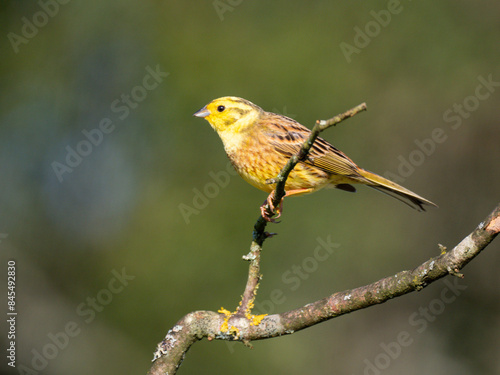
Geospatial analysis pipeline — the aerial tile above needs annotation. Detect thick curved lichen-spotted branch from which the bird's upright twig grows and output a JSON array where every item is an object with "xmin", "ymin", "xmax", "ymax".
[{"xmin": 148, "ymin": 204, "xmax": 500, "ymax": 375}]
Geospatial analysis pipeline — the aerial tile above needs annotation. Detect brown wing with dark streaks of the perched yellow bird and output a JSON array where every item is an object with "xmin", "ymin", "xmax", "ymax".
[{"xmin": 261, "ymin": 112, "xmax": 360, "ymax": 178}]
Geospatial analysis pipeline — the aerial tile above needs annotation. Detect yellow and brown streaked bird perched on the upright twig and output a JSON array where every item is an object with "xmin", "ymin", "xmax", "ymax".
[{"xmin": 194, "ymin": 96, "xmax": 436, "ymax": 221}]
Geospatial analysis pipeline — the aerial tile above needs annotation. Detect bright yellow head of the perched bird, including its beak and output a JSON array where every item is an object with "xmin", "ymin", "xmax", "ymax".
[{"xmin": 193, "ymin": 96, "xmax": 264, "ymax": 134}]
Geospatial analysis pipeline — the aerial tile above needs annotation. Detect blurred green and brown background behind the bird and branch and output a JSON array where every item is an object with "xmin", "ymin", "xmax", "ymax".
[{"xmin": 0, "ymin": 0, "xmax": 500, "ymax": 375}]
